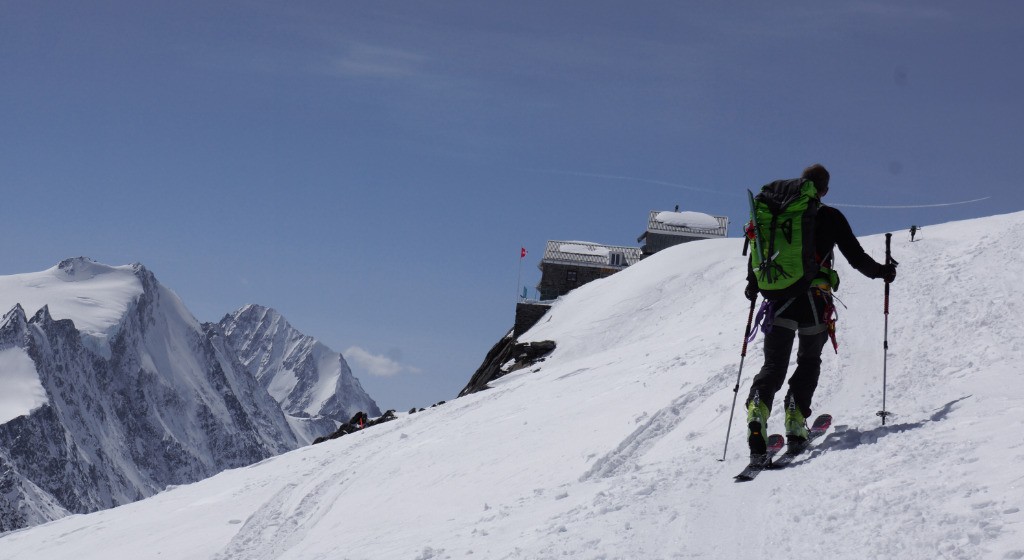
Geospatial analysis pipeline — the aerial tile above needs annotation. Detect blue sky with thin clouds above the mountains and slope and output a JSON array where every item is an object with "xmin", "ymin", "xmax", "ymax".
[{"xmin": 0, "ymin": 0, "xmax": 1024, "ymax": 410}]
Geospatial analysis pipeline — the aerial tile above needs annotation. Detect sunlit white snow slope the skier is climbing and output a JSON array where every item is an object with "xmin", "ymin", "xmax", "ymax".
[{"xmin": 0, "ymin": 213, "xmax": 1024, "ymax": 560}]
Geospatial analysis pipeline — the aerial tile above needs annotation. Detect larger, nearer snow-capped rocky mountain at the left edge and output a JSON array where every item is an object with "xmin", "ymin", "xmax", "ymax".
[{"xmin": 0, "ymin": 258, "xmax": 373, "ymax": 531}]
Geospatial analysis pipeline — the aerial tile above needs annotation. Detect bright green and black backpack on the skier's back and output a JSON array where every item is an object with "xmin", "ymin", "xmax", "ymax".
[{"xmin": 746, "ymin": 179, "xmax": 821, "ymax": 300}]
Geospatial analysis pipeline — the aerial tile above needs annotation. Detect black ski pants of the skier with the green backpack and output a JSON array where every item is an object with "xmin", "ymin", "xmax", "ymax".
[{"xmin": 746, "ymin": 294, "xmax": 828, "ymax": 418}]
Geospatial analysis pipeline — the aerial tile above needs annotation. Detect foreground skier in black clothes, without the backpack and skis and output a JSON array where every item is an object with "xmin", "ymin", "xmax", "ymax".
[{"xmin": 743, "ymin": 164, "xmax": 896, "ymax": 456}]
